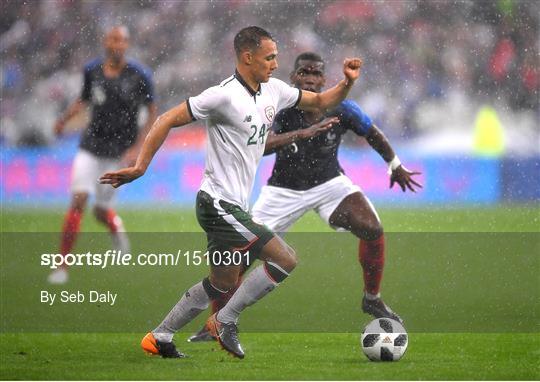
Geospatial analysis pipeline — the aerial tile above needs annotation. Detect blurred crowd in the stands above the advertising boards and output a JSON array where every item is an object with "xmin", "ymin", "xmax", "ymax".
[{"xmin": 0, "ymin": 0, "xmax": 540, "ymax": 143}]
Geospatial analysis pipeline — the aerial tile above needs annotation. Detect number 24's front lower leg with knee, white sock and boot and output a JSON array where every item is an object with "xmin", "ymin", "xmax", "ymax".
[{"xmin": 207, "ymin": 236, "xmax": 297, "ymax": 358}]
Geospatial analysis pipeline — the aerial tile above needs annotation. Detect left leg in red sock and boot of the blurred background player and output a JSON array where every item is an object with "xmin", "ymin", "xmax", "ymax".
[{"xmin": 47, "ymin": 192, "xmax": 88, "ymax": 284}]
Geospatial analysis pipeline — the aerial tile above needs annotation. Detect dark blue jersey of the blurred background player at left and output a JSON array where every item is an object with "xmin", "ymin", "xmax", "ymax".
[{"xmin": 80, "ymin": 59, "xmax": 154, "ymax": 158}]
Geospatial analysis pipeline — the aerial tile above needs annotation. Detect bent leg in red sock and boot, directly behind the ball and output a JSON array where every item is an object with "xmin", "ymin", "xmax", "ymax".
[{"xmin": 329, "ymin": 192, "xmax": 403, "ymax": 322}]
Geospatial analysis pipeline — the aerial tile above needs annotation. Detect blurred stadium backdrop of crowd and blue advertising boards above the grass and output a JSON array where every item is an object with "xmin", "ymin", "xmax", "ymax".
[{"xmin": 0, "ymin": 0, "xmax": 540, "ymax": 209}]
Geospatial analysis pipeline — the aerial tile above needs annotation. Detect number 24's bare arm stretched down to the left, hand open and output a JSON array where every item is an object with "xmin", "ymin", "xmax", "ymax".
[{"xmin": 99, "ymin": 102, "xmax": 192, "ymax": 188}]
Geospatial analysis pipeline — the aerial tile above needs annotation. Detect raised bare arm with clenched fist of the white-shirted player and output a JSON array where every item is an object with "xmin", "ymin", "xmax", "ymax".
[{"xmin": 298, "ymin": 58, "xmax": 362, "ymax": 112}]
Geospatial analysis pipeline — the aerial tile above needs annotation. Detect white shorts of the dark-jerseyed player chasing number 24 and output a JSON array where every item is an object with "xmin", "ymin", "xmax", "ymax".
[{"xmin": 252, "ymin": 175, "xmax": 362, "ymax": 233}]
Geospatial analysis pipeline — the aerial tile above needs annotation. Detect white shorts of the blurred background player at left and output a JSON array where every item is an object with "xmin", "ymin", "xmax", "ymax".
[{"xmin": 71, "ymin": 150, "xmax": 120, "ymax": 208}]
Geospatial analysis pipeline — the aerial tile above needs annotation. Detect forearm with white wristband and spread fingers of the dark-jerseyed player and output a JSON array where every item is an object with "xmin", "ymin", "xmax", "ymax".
[{"xmin": 365, "ymin": 125, "xmax": 422, "ymax": 192}]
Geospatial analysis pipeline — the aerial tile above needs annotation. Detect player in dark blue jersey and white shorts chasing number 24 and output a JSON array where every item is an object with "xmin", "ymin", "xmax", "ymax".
[{"xmin": 189, "ymin": 52, "xmax": 422, "ymax": 342}]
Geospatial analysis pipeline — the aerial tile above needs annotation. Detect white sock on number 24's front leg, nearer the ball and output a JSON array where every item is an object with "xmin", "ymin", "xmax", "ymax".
[{"xmin": 216, "ymin": 264, "xmax": 279, "ymax": 323}]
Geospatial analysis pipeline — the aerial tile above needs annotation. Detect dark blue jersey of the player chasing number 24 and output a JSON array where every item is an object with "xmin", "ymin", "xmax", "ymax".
[{"xmin": 268, "ymin": 100, "xmax": 373, "ymax": 191}]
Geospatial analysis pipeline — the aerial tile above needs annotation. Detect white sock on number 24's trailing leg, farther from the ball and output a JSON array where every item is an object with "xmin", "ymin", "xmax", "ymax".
[{"xmin": 152, "ymin": 281, "xmax": 210, "ymax": 342}]
